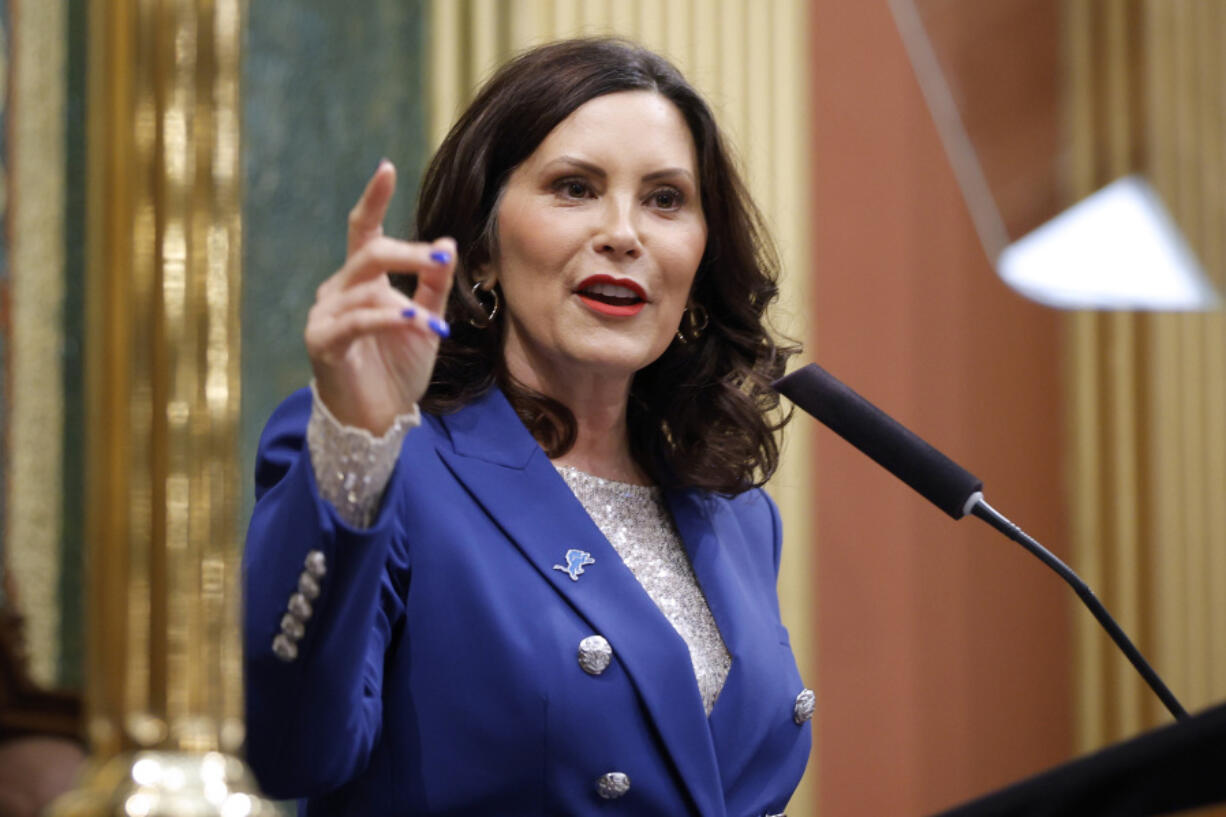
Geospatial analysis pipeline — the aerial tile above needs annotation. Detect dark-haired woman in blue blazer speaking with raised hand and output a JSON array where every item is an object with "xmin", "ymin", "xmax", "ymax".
[{"xmin": 244, "ymin": 39, "xmax": 813, "ymax": 817}]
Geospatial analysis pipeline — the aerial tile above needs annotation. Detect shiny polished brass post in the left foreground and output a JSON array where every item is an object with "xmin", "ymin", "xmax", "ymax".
[{"xmin": 53, "ymin": 0, "xmax": 270, "ymax": 817}]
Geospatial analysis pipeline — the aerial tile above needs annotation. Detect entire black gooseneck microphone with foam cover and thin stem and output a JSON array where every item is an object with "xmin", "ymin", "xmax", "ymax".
[{"xmin": 771, "ymin": 363, "xmax": 1188, "ymax": 720}]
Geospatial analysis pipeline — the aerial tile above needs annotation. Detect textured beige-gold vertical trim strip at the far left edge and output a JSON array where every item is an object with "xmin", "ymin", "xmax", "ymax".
[{"xmin": 4, "ymin": 0, "xmax": 67, "ymax": 688}]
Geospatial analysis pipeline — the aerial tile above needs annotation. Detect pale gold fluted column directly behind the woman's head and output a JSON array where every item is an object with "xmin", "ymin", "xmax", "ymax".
[{"xmin": 428, "ymin": 0, "xmax": 820, "ymax": 815}]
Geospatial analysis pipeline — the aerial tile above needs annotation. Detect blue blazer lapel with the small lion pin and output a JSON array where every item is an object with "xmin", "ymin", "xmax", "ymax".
[{"xmin": 439, "ymin": 390, "xmax": 725, "ymax": 817}]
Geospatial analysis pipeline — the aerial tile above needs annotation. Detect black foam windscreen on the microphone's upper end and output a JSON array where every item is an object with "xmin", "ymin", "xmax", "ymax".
[{"xmin": 771, "ymin": 363, "xmax": 983, "ymax": 519}]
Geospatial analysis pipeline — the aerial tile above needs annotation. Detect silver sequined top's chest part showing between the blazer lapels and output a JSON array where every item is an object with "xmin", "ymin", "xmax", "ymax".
[{"xmin": 554, "ymin": 465, "xmax": 732, "ymax": 715}]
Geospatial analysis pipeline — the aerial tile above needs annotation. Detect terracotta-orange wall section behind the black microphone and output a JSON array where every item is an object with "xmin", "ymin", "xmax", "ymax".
[{"xmin": 814, "ymin": 0, "xmax": 1075, "ymax": 817}]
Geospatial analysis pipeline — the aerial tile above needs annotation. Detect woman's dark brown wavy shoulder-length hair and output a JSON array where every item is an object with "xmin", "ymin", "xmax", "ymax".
[{"xmin": 416, "ymin": 38, "xmax": 797, "ymax": 494}]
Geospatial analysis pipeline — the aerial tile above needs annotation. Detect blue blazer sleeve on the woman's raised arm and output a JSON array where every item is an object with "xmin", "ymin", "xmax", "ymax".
[{"xmin": 243, "ymin": 389, "xmax": 409, "ymax": 797}]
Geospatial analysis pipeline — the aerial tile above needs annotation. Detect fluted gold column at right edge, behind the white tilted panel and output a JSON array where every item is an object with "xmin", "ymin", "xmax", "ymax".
[{"xmin": 1067, "ymin": 0, "xmax": 1226, "ymax": 751}]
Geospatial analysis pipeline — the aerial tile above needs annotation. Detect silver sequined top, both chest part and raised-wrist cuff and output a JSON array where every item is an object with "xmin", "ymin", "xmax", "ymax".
[{"xmin": 307, "ymin": 382, "xmax": 732, "ymax": 715}]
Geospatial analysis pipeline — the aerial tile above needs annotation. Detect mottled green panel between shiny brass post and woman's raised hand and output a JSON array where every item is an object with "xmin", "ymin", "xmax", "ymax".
[{"xmin": 242, "ymin": 0, "xmax": 428, "ymax": 523}]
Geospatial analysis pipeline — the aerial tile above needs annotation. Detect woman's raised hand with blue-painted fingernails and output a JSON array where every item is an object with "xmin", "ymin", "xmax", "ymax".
[{"xmin": 304, "ymin": 159, "xmax": 456, "ymax": 435}]
